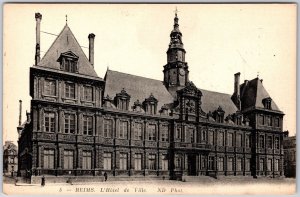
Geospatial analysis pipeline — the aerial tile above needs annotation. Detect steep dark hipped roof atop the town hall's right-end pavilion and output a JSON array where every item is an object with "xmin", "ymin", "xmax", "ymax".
[{"xmin": 240, "ymin": 78, "xmax": 280, "ymax": 111}]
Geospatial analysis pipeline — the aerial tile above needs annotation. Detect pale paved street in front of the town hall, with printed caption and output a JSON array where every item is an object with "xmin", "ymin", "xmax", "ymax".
[{"xmin": 3, "ymin": 177, "xmax": 296, "ymax": 195}]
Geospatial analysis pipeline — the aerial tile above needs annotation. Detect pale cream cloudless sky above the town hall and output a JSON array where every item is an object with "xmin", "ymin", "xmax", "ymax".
[{"xmin": 3, "ymin": 4, "xmax": 296, "ymax": 145}]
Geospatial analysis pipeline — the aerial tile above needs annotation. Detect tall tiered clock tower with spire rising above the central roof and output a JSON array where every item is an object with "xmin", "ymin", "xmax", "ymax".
[{"xmin": 163, "ymin": 9, "xmax": 189, "ymax": 97}]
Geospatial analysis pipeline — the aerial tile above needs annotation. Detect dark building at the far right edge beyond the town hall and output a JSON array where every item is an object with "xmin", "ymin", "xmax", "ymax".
[{"xmin": 283, "ymin": 132, "xmax": 297, "ymax": 178}]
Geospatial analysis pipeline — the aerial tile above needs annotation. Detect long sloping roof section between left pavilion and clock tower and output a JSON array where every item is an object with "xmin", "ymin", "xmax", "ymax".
[{"xmin": 104, "ymin": 70, "xmax": 173, "ymax": 110}]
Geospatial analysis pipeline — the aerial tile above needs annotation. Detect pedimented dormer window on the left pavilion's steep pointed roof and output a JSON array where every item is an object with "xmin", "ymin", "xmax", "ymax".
[{"xmin": 57, "ymin": 51, "xmax": 79, "ymax": 73}]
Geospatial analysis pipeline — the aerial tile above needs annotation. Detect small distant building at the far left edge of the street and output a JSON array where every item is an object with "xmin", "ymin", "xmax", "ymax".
[{"xmin": 3, "ymin": 141, "xmax": 18, "ymax": 176}]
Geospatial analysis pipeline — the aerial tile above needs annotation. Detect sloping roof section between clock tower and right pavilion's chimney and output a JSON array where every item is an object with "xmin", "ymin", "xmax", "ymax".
[{"xmin": 200, "ymin": 89, "xmax": 238, "ymax": 117}]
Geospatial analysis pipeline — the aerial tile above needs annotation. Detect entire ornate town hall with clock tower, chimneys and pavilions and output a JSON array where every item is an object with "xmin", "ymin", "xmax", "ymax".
[{"xmin": 18, "ymin": 13, "xmax": 284, "ymax": 182}]
